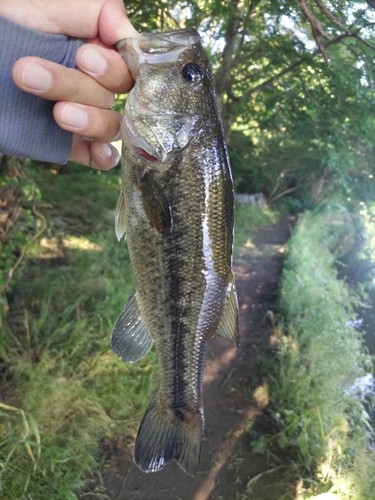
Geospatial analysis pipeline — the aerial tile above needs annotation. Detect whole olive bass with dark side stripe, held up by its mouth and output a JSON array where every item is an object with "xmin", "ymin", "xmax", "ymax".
[{"xmin": 111, "ymin": 28, "xmax": 239, "ymax": 476}]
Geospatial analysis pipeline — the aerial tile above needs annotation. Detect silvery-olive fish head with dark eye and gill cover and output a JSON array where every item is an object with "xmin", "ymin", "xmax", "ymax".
[{"xmin": 117, "ymin": 29, "xmax": 212, "ymax": 171}]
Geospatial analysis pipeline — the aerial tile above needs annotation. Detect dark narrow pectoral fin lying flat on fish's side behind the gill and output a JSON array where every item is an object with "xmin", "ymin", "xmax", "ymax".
[{"xmin": 139, "ymin": 172, "xmax": 172, "ymax": 233}]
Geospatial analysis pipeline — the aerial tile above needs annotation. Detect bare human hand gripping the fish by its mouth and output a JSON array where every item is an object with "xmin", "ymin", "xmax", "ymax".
[{"xmin": 0, "ymin": 0, "xmax": 138, "ymax": 170}]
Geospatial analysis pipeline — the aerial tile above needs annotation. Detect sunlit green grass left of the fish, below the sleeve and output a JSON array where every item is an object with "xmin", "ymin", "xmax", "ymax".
[{"xmin": 0, "ymin": 164, "xmax": 157, "ymax": 500}]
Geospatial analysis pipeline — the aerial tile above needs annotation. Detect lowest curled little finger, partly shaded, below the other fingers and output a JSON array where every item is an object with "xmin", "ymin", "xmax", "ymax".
[{"xmin": 69, "ymin": 135, "xmax": 120, "ymax": 170}]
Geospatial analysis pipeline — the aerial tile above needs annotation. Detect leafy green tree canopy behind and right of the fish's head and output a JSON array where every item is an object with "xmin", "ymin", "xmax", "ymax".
[{"xmin": 121, "ymin": 0, "xmax": 375, "ymax": 208}]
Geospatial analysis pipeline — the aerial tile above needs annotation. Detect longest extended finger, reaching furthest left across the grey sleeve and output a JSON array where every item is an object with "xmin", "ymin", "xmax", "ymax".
[{"xmin": 12, "ymin": 57, "xmax": 114, "ymax": 108}]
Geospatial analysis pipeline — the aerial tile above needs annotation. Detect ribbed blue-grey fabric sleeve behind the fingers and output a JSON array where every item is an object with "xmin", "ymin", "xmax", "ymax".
[{"xmin": 0, "ymin": 16, "xmax": 84, "ymax": 164}]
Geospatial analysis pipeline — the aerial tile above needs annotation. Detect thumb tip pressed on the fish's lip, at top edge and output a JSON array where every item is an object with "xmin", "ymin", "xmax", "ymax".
[{"xmin": 98, "ymin": 0, "xmax": 139, "ymax": 45}]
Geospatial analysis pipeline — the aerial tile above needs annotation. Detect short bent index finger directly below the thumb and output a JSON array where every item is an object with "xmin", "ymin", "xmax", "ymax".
[{"xmin": 76, "ymin": 43, "xmax": 134, "ymax": 94}]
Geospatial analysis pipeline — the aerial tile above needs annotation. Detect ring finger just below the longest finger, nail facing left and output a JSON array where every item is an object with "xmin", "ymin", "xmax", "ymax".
[{"xmin": 53, "ymin": 101, "xmax": 122, "ymax": 142}]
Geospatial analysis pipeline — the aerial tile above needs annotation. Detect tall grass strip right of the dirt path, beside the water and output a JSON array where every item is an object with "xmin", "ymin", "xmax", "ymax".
[{"xmin": 253, "ymin": 208, "xmax": 375, "ymax": 499}]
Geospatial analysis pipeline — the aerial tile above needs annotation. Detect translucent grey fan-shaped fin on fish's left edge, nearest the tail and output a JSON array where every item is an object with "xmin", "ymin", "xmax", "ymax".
[{"xmin": 111, "ymin": 293, "xmax": 153, "ymax": 363}]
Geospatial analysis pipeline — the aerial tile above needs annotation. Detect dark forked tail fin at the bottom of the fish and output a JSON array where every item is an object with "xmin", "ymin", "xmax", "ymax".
[{"xmin": 134, "ymin": 399, "xmax": 204, "ymax": 476}]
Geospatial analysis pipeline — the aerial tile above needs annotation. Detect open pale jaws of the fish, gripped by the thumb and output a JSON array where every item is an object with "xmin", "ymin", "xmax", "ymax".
[{"xmin": 116, "ymin": 28, "xmax": 200, "ymax": 80}]
